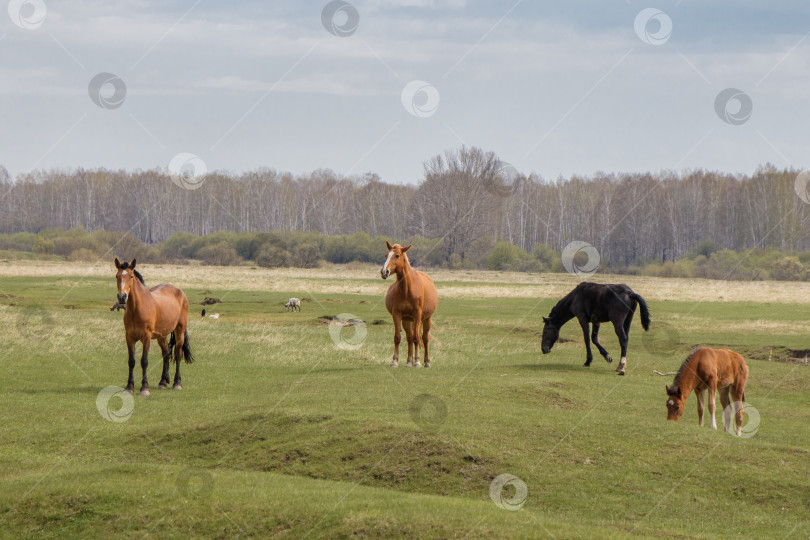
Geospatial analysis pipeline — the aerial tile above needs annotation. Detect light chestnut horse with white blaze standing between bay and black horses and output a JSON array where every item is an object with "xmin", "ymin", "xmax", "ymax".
[{"xmin": 380, "ymin": 241, "xmax": 439, "ymax": 367}]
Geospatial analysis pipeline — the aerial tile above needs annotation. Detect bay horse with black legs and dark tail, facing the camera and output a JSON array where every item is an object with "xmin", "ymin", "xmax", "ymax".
[{"xmin": 115, "ymin": 259, "xmax": 194, "ymax": 396}]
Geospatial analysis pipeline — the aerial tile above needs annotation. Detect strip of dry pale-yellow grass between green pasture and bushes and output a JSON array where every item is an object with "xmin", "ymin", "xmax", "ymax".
[{"xmin": 0, "ymin": 261, "xmax": 810, "ymax": 304}]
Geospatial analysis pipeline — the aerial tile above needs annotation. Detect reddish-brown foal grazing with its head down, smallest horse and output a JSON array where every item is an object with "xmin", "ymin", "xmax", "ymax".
[{"xmin": 666, "ymin": 347, "xmax": 748, "ymax": 436}]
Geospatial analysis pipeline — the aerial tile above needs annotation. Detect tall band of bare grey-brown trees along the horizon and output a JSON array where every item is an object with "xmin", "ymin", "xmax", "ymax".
[{"xmin": 0, "ymin": 148, "xmax": 810, "ymax": 271}]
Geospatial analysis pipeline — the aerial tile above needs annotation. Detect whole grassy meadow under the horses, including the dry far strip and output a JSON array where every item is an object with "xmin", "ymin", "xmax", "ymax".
[{"xmin": 0, "ymin": 261, "xmax": 810, "ymax": 538}]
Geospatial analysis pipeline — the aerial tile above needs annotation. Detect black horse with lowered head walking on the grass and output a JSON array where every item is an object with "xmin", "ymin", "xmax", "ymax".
[{"xmin": 542, "ymin": 281, "xmax": 650, "ymax": 375}]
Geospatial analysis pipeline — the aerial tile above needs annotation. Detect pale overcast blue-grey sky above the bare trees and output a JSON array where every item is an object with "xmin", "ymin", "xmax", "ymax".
[{"xmin": 0, "ymin": 0, "xmax": 810, "ymax": 182}]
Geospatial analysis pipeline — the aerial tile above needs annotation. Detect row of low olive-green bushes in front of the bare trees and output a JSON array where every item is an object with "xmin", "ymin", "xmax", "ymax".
[{"xmin": 0, "ymin": 227, "xmax": 810, "ymax": 281}]
